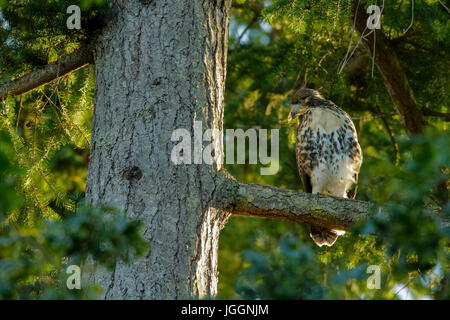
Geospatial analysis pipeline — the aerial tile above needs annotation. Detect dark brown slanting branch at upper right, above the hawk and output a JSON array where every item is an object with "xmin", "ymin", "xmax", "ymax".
[{"xmin": 352, "ymin": 1, "xmax": 425, "ymax": 134}]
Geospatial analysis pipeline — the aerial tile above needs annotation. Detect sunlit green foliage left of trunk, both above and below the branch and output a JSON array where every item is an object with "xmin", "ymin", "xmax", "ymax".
[{"xmin": 0, "ymin": 0, "xmax": 99, "ymax": 225}]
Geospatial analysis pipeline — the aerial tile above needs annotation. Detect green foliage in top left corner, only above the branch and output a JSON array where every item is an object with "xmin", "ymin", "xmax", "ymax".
[{"xmin": 0, "ymin": 0, "xmax": 111, "ymax": 84}]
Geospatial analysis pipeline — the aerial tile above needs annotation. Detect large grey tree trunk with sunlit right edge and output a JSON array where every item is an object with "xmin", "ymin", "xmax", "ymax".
[{"xmin": 86, "ymin": 0, "xmax": 231, "ymax": 299}]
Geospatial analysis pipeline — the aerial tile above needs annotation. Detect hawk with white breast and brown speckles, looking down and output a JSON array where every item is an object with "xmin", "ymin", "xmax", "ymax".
[{"xmin": 289, "ymin": 89, "xmax": 362, "ymax": 247}]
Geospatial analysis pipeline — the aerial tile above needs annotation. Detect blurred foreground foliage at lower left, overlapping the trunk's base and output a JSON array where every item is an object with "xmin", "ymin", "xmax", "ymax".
[{"xmin": 0, "ymin": 131, "xmax": 147, "ymax": 299}]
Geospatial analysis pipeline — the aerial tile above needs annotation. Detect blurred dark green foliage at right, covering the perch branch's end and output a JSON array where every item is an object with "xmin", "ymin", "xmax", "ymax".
[{"xmin": 356, "ymin": 131, "xmax": 450, "ymax": 292}]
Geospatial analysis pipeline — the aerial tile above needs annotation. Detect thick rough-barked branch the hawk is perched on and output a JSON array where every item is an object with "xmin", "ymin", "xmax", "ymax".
[{"xmin": 215, "ymin": 174, "xmax": 450, "ymax": 230}]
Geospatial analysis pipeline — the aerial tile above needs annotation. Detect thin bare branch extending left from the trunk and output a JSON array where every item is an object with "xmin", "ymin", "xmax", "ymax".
[{"xmin": 0, "ymin": 45, "xmax": 93, "ymax": 100}]
